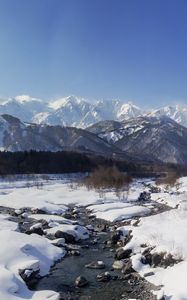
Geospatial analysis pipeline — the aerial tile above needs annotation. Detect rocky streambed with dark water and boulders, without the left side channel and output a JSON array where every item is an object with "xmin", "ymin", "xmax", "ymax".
[{"xmin": 29, "ymin": 205, "xmax": 167, "ymax": 300}]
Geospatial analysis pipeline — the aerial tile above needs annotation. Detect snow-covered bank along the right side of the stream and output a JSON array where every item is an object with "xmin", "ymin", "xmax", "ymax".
[{"xmin": 118, "ymin": 177, "xmax": 187, "ymax": 300}]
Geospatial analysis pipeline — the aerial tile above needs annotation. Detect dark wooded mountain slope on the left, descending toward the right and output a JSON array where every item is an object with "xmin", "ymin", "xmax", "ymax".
[{"xmin": 0, "ymin": 115, "xmax": 125, "ymax": 157}]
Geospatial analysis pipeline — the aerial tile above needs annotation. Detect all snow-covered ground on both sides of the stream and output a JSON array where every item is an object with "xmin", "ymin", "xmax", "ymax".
[{"xmin": 0, "ymin": 178, "xmax": 187, "ymax": 300}]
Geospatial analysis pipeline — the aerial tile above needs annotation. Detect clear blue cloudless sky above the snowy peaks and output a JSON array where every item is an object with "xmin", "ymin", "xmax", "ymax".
[{"xmin": 0, "ymin": 0, "xmax": 187, "ymax": 106}]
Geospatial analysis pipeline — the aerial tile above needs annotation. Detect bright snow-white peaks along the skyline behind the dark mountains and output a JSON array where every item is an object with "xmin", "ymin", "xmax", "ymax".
[{"xmin": 0, "ymin": 95, "xmax": 187, "ymax": 128}]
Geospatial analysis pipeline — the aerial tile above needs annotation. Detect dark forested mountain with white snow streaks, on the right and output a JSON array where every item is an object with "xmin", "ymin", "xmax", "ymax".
[{"xmin": 88, "ymin": 116, "xmax": 187, "ymax": 164}]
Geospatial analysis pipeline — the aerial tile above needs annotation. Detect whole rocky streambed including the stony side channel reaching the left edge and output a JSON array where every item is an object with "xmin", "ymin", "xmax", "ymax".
[{"xmin": 0, "ymin": 190, "xmax": 169, "ymax": 300}]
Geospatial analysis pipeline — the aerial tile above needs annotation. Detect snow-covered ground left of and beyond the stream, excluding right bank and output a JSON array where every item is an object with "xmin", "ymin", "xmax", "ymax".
[{"xmin": 0, "ymin": 178, "xmax": 152, "ymax": 300}]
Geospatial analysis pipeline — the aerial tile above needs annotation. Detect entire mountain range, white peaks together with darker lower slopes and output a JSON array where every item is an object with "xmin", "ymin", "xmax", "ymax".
[{"xmin": 0, "ymin": 95, "xmax": 187, "ymax": 164}]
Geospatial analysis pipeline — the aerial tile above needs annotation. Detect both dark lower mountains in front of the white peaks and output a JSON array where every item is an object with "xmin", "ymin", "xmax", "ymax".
[{"xmin": 0, "ymin": 114, "xmax": 187, "ymax": 164}]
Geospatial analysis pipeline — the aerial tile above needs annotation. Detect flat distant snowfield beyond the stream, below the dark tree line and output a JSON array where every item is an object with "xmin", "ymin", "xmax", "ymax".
[{"xmin": 0, "ymin": 180, "xmax": 148, "ymax": 214}]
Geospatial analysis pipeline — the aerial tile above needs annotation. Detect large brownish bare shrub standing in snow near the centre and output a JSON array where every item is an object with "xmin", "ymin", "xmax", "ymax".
[{"xmin": 80, "ymin": 166, "xmax": 132, "ymax": 199}]
